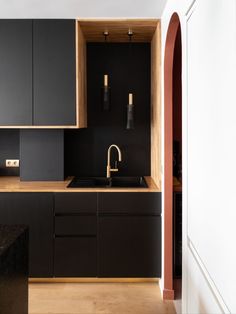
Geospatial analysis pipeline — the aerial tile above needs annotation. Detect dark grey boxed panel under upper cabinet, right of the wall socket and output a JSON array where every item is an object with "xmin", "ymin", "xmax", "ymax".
[{"xmin": 20, "ymin": 129, "xmax": 64, "ymax": 181}]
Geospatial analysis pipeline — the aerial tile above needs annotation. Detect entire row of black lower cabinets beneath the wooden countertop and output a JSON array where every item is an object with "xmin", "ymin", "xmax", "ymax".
[{"xmin": 0, "ymin": 192, "xmax": 161, "ymax": 277}]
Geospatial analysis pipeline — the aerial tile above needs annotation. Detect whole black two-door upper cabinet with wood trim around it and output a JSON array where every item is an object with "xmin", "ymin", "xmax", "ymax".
[{"xmin": 0, "ymin": 20, "xmax": 76, "ymax": 127}]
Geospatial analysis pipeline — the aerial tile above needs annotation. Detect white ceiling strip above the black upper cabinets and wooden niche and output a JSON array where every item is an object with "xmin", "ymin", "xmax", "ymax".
[{"xmin": 0, "ymin": 0, "xmax": 167, "ymax": 18}]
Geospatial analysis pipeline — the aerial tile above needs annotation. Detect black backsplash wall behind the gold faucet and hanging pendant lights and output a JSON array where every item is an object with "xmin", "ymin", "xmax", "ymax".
[{"xmin": 65, "ymin": 43, "xmax": 151, "ymax": 176}]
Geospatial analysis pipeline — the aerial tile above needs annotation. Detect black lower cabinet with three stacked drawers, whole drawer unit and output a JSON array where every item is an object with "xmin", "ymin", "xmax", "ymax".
[{"xmin": 54, "ymin": 193, "xmax": 97, "ymax": 277}]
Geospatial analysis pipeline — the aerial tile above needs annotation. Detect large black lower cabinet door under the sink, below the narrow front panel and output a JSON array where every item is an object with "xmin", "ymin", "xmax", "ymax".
[{"xmin": 98, "ymin": 215, "xmax": 161, "ymax": 277}]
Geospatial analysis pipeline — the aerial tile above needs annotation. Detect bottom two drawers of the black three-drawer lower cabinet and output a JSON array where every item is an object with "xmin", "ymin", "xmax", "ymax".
[{"xmin": 54, "ymin": 214, "xmax": 97, "ymax": 277}]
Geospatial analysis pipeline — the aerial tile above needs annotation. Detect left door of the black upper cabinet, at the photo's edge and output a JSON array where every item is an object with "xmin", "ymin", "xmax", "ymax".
[{"xmin": 0, "ymin": 20, "xmax": 32, "ymax": 126}]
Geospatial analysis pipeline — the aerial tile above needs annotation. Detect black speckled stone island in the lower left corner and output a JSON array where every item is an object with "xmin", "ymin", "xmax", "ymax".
[{"xmin": 0, "ymin": 225, "xmax": 29, "ymax": 314}]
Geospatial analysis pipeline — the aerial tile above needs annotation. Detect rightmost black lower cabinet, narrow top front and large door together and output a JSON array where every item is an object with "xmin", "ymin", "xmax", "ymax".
[{"xmin": 98, "ymin": 192, "xmax": 161, "ymax": 277}]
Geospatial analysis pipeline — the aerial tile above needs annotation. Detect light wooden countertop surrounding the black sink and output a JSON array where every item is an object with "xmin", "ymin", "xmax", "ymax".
[{"xmin": 0, "ymin": 176, "xmax": 160, "ymax": 192}]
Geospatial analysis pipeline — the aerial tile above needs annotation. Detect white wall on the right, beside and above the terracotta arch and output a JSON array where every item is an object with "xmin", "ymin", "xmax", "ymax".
[{"xmin": 162, "ymin": 0, "xmax": 236, "ymax": 314}]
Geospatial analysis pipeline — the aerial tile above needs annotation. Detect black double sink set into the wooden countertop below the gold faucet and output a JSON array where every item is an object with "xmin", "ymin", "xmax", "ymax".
[{"xmin": 67, "ymin": 177, "xmax": 148, "ymax": 188}]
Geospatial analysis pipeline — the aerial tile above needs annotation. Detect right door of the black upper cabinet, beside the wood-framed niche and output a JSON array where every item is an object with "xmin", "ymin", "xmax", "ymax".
[{"xmin": 33, "ymin": 20, "xmax": 76, "ymax": 125}]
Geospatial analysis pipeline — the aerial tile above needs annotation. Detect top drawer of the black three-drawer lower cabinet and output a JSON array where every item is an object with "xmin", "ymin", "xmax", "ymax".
[{"xmin": 55, "ymin": 192, "xmax": 97, "ymax": 214}]
